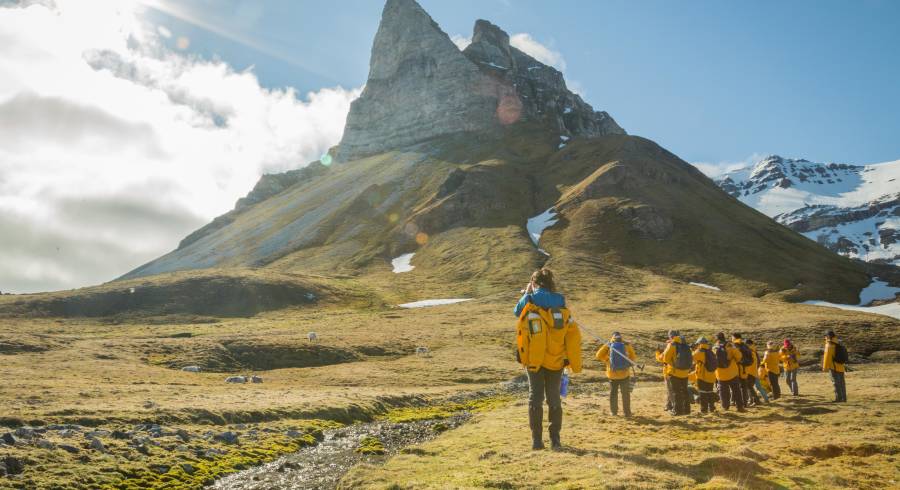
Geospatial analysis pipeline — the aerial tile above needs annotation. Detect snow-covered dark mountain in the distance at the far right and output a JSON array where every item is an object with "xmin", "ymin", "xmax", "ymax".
[{"xmin": 716, "ymin": 155, "xmax": 900, "ymax": 265}]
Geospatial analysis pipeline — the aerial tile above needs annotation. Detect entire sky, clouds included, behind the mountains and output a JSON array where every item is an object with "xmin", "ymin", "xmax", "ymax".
[{"xmin": 0, "ymin": 0, "xmax": 900, "ymax": 292}]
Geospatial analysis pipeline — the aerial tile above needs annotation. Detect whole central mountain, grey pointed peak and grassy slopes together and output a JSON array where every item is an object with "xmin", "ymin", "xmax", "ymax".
[{"xmin": 109, "ymin": 0, "xmax": 871, "ymax": 310}]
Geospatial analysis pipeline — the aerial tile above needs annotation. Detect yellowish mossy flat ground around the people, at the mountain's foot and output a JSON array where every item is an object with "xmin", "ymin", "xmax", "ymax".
[{"xmin": 0, "ymin": 266, "xmax": 900, "ymax": 488}]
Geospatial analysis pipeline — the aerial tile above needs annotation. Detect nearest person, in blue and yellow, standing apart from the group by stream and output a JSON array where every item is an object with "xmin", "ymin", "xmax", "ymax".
[{"xmin": 515, "ymin": 268, "xmax": 581, "ymax": 450}]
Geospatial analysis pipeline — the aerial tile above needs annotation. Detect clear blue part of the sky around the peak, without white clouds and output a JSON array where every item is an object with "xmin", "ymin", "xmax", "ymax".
[{"xmin": 147, "ymin": 0, "xmax": 900, "ymax": 168}]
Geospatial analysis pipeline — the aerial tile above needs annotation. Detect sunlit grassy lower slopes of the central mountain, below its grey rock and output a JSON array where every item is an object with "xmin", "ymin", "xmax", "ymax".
[{"xmin": 116, "ymin": 125, "xmax": 869, "ymax": 303}]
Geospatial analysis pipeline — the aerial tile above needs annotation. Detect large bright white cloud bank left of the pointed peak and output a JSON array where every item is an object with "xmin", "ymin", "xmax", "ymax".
[{"xmin": 0, "ymin": 0, "xmax": 359, "ymax": 292}]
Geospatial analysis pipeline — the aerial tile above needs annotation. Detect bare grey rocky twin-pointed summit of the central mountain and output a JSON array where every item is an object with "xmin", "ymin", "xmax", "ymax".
[{"xmin": 337, "ymin": 0, "xmax": 624, "ymax": 161}]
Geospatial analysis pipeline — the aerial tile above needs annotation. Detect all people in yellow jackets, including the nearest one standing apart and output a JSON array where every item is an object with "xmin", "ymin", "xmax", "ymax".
[{"xmin": 514, "ymin": 268, "xmax": 848, "ymax": 449}]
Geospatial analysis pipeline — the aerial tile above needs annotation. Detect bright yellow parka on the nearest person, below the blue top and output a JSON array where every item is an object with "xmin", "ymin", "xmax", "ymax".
[{"xmin": 516, "ymin": 303, "xmax": 581, "ymax": 373}]
